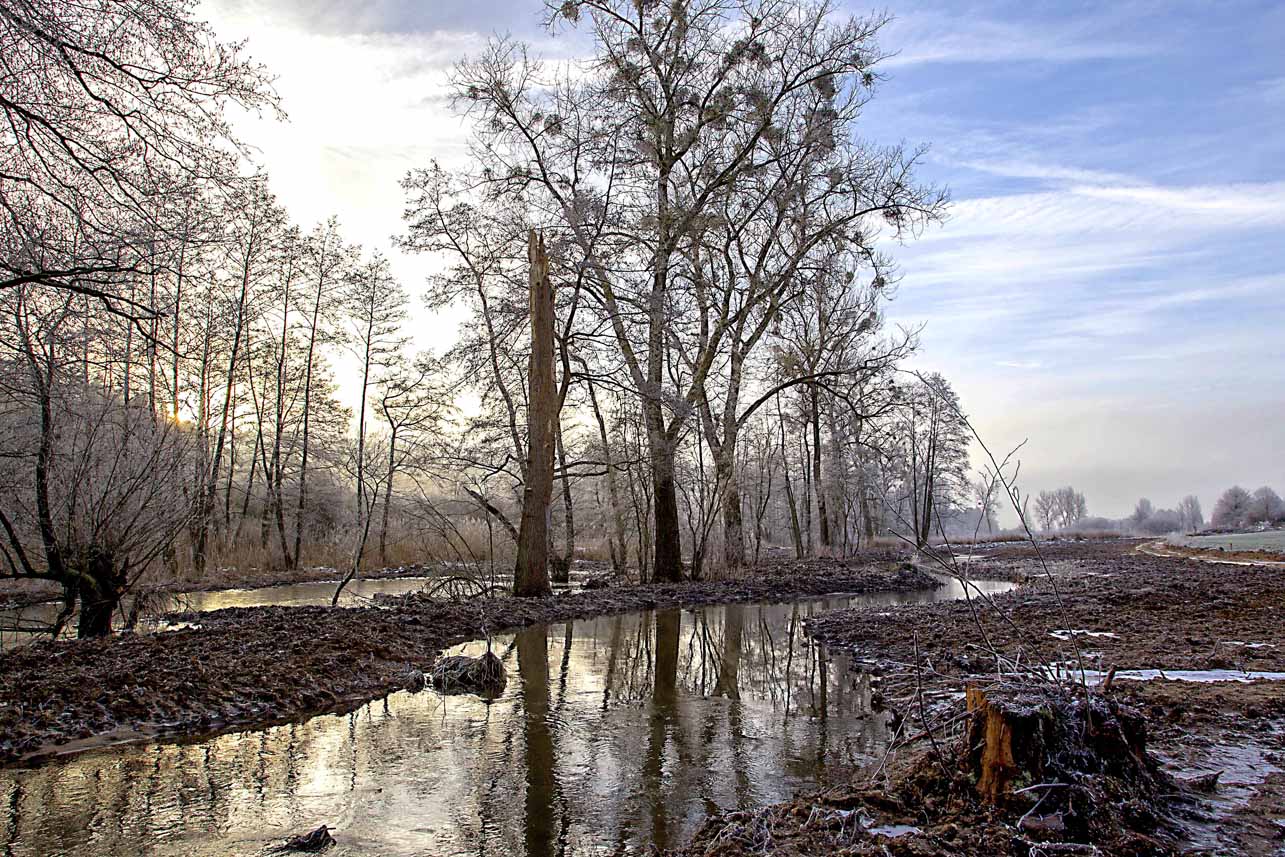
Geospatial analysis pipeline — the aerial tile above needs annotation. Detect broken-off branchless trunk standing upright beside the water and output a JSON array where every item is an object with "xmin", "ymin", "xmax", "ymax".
[{"xmin": 513, "ymin": 230, "xmax": 558, "ymax": 597}]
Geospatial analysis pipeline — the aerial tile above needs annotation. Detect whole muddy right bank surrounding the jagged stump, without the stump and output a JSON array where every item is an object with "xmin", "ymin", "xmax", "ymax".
[{"xmin": 684, "ymin": 545, "xmax": 1285, "ymax": 857}]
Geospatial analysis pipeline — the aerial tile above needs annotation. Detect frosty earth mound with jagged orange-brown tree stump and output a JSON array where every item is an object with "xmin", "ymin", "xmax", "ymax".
[{"xmin": 676, "ymin": 682, "xmax": 1190, "ymax": 857}]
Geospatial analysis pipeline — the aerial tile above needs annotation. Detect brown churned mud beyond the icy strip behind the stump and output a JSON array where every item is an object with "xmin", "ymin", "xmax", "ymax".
[{"xmin": 810, "ymin": 554, "xmax": 1285, "ymax": 675}]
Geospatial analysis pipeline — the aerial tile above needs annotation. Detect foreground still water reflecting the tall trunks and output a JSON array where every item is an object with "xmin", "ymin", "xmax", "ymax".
[{"xmin": 0, "ymin": 585, "xmax": 1009, "ymax": 857}]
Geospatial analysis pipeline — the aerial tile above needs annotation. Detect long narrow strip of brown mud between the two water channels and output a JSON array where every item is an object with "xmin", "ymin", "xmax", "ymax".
[{"xmin": 0, "ymin": 560, "xmax": 937, "ymax": 762}]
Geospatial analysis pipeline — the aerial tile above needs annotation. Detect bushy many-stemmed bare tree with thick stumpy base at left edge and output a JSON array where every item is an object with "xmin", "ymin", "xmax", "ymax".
[{"xmin": 0, "ymin": 287, "xmax": 194, "ymax": 637}]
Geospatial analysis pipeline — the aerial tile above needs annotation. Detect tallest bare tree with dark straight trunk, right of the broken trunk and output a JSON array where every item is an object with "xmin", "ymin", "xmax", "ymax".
[{"xmin": 456, "ymin": 0, "xmax": 935, "ymax": 581}]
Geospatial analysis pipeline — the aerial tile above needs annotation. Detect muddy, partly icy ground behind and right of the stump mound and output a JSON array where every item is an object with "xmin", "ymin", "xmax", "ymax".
[{"xmin": 791, "ymin": 545, "xmax": 1285, "ymax": 857}]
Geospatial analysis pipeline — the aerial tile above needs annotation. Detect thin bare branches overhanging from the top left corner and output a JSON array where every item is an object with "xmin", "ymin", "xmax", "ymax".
[{"xmin": 0, "ymin": 0, "xmax": 276, "ymax": 317}]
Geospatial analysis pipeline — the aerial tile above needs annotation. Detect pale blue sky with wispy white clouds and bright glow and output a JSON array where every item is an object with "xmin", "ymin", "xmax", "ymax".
[{"xmin": 199, "ymin": 0, "xmax": 1285, "ymax": 518}]
